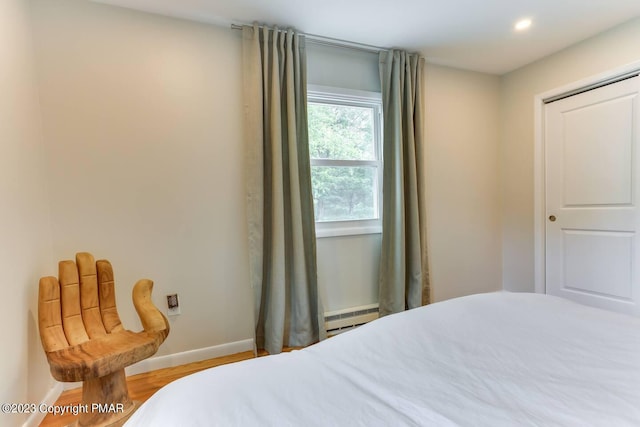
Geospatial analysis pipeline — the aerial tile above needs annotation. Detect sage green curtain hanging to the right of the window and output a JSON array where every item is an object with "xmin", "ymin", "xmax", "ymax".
[{"xmin": 379, "ymin": 50, "xmax": 430, "ymax": 316}]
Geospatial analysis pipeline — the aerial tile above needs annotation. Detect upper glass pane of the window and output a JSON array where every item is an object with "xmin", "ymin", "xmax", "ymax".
[{"xmin": 308, "ymin": 102, "xmax": 376, "ymax": 160}]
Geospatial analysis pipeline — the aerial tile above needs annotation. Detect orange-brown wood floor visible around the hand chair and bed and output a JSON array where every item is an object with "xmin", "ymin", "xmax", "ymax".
[{"xmin": 40, "ymin": 349, "xmax": 260, "ymax": 427}]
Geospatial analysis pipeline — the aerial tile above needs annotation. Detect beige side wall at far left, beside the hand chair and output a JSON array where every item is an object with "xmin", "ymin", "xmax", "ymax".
[{"xmin": 0, "ymin": 0, "xmax": 54, "ymax": 426}]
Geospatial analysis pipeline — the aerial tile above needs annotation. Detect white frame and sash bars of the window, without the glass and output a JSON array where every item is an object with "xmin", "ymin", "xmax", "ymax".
[{"xmin": 307, "ymin": 85, "xmax": 383, "ymax": 238}]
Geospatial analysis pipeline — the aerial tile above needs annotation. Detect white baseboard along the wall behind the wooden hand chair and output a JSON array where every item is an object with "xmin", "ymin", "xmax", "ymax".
[{"xmin": 28, "ymin": 338, "xmax": 256, "ymax": 427}]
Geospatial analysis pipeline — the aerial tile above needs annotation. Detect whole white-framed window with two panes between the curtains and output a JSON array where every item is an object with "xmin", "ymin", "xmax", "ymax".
[{"xmin": 307, "ymin": 86, "xmax": 382, "ymax": 237}]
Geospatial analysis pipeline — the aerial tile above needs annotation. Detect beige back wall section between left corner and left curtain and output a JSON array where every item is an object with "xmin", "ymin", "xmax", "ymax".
[{"xmin": 33, "ymin": 0, "xmax": 253, "ymax": 355}]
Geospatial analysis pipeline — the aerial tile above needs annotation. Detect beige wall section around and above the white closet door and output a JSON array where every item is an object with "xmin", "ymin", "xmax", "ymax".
[{"xmin": 500, "ymin": 15, "xmax": 640, "ymax": 292}]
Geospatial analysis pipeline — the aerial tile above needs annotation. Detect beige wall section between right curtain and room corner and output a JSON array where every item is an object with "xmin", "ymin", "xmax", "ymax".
[{"xmin": 425, "ymin": 65, "xmax": 501, "ymax": 301}]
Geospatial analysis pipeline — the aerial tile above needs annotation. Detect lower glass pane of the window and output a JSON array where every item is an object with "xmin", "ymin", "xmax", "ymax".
[{"xmin": 311, "ymin": 166, "xmax": 378, "ymax": 222}]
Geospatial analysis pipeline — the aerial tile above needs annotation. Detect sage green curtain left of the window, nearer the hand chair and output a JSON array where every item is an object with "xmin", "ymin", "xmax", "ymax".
[{"xmin": 243, "ymin": 26, "xmax": 326, "ymax": 354}]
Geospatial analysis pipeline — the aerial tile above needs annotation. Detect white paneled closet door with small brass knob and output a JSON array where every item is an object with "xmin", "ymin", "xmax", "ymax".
[{"xmin": 545, "ymin": 77, "xmax": 640, "ymax": 315}]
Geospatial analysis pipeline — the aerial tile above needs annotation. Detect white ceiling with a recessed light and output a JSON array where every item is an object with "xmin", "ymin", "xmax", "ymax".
[{"xmin": 95, "ymin": 0, "xmax": 640, "ymax": 74}]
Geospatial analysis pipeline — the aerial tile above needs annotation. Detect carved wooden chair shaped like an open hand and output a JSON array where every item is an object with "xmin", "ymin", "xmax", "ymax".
[{"xmin": 38, "ymin": 253, "xmax": 169, "ymax": 426}]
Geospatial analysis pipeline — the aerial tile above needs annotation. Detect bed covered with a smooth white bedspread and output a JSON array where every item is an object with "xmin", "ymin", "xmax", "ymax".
[{"xmin": 126, "ymin": 292, "xmax": 640, "ymax": 427}]
